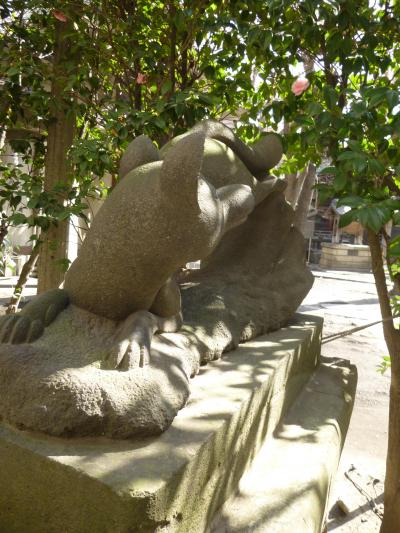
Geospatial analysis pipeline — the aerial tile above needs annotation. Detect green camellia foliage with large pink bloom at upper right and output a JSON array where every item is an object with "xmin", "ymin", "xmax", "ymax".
[{"xmin": 244, "ymin": 0, "xmax": 400, "ymax": 237}]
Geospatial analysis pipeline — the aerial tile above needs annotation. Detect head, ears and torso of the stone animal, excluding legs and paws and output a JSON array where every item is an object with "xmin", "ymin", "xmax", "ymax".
[{"xmin": 65, "ymin": 122, "xmax": 282, "ymax": 320}]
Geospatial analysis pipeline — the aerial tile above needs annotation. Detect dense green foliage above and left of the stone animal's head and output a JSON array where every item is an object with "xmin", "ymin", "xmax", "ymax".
[{"xmin": 0, "ymin": 0, "xmax": 284, "ymax": 245}]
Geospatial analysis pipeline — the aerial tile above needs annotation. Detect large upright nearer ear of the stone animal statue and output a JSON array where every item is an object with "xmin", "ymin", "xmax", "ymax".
[{"xmin": 160, "ymin": 131, "xmax": 205, "ymax": 203}]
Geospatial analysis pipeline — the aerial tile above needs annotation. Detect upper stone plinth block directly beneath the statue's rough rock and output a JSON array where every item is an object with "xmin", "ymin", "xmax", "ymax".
[{"xmin": 0, "ymin": 315, "xmax": 322, "ymax": 533}]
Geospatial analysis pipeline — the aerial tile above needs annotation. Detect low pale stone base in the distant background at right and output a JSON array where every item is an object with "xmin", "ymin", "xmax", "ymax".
[{"xmin": 319, "ymin": 242, "xmax": 371, "ymax": 272}]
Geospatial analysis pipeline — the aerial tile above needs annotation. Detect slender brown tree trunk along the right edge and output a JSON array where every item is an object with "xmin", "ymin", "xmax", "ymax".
[{"xmin": 368, "ymin": 229, "xmax": 400, "ymax": 533}]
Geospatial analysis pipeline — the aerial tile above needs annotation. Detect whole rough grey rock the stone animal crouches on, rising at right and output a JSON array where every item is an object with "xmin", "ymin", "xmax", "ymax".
[{"xmin": 0, "ymin": 187, "xmax": 313, "ymax": 438}]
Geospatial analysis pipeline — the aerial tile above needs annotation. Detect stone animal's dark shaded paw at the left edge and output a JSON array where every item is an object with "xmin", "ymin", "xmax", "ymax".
[{"xmin": 0, "ymin": 314, "xmax": 44, "ymax": 344}]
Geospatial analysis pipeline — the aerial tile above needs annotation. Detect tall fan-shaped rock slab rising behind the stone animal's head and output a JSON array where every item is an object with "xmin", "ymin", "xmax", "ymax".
[{"xmin": 182, "ymin": 192, "xmax": 313, "ymax": 362}]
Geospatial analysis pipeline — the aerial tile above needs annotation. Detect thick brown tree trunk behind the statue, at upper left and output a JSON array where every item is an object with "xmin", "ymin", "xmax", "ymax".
[{"xmin": 38, "ymin": 21, "xmax": 75, "ymax": 293}]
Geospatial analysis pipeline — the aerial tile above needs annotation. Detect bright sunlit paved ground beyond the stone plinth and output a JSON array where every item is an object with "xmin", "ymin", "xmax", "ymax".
[{"xmin": 0, "ymin": 269, "xmax": 389, "ymax": 533}]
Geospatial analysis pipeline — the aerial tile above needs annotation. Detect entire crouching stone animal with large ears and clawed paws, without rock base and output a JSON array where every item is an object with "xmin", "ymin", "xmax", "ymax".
[{"xmin": 0, "ymin": 121, "xmax": 282, "ymax": 369}]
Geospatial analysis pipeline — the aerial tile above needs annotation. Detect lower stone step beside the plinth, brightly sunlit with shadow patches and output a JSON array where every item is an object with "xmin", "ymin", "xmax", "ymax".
[{"xmin": 210, "ymin": 360, "xmax": 357, "ymax": 533}]
